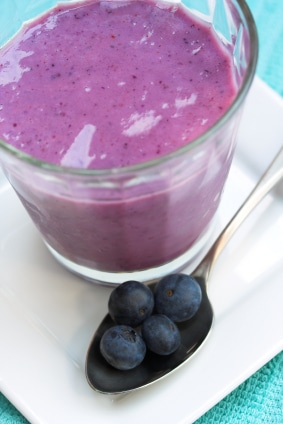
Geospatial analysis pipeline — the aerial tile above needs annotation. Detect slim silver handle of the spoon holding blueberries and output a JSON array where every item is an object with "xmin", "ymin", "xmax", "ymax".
[{"xmin": 193, "ymin": 147, "xmax": 283, "ymax": 280}]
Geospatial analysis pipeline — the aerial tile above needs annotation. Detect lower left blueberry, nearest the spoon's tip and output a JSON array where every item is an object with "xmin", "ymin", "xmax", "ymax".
[{"xmin": 100, "ymin": 325, "xmax": 146, "ymax": 370}]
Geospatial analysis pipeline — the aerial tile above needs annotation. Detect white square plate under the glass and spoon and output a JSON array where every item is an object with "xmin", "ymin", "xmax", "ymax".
[{"xmin": 0, "ymin": 79, "xmax": 283, "ymax": 424}]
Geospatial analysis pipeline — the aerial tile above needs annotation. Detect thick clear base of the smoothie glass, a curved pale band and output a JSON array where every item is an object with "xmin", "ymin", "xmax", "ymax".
[{"xmin": 45, "ymin": 225, "xmax": 214, "ymax": 286}]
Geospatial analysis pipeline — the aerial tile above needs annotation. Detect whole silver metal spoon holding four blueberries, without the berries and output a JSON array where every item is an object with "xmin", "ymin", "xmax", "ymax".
[{"xmin": 85, "ymin": 147, "xmax": 283, "ymax": 394}]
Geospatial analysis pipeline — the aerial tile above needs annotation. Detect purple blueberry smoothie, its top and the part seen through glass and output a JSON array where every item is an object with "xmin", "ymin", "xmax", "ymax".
[{"xmin": 0, "ymin": 0, "xmax": 240, "ymax": 272}]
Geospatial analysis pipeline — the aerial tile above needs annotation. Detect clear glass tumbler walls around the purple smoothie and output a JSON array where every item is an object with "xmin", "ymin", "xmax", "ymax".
[{"xmin": 0, "ymin": 0, "xmax": 258, "ymax": 285}]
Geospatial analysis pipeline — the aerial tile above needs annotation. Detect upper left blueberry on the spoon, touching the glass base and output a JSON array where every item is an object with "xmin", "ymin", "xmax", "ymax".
[{"xmin": 108, "ymin": 281, "xmax": 154, "ymax": 327}]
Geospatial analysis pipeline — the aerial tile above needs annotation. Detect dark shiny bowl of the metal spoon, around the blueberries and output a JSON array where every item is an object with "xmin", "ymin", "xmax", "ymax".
[{"xmin": 86, "ymin": 278, "xmax": 213, "ymax": 394}]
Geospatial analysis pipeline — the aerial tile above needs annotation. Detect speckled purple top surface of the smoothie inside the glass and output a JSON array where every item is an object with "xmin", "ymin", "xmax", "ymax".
[{"xmin": 0, "ymin": 0, "xmax": 236, "ymax": 169}]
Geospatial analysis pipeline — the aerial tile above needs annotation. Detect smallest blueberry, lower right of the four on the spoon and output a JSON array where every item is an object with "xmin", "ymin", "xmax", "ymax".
[{"xmin": 142, "ymin": 314, "xmax": 181, "ymax": 355}]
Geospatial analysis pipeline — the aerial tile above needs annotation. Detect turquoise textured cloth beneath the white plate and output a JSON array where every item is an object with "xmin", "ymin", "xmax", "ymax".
[{"xmin": 0, "ymin": 0, "xmax": 283, "ymax": 424}]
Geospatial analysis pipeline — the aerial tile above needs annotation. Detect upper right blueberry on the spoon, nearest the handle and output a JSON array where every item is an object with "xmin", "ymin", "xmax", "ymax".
[{"xmin": 154, "ymin": 274, "xmax": 202, "ymax": 322}]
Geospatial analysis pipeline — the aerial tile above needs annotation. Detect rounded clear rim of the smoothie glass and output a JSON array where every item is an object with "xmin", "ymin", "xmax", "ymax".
[{"xmin": 0, "ymin": 0, "xmax": 259, "ymax": 177}]
